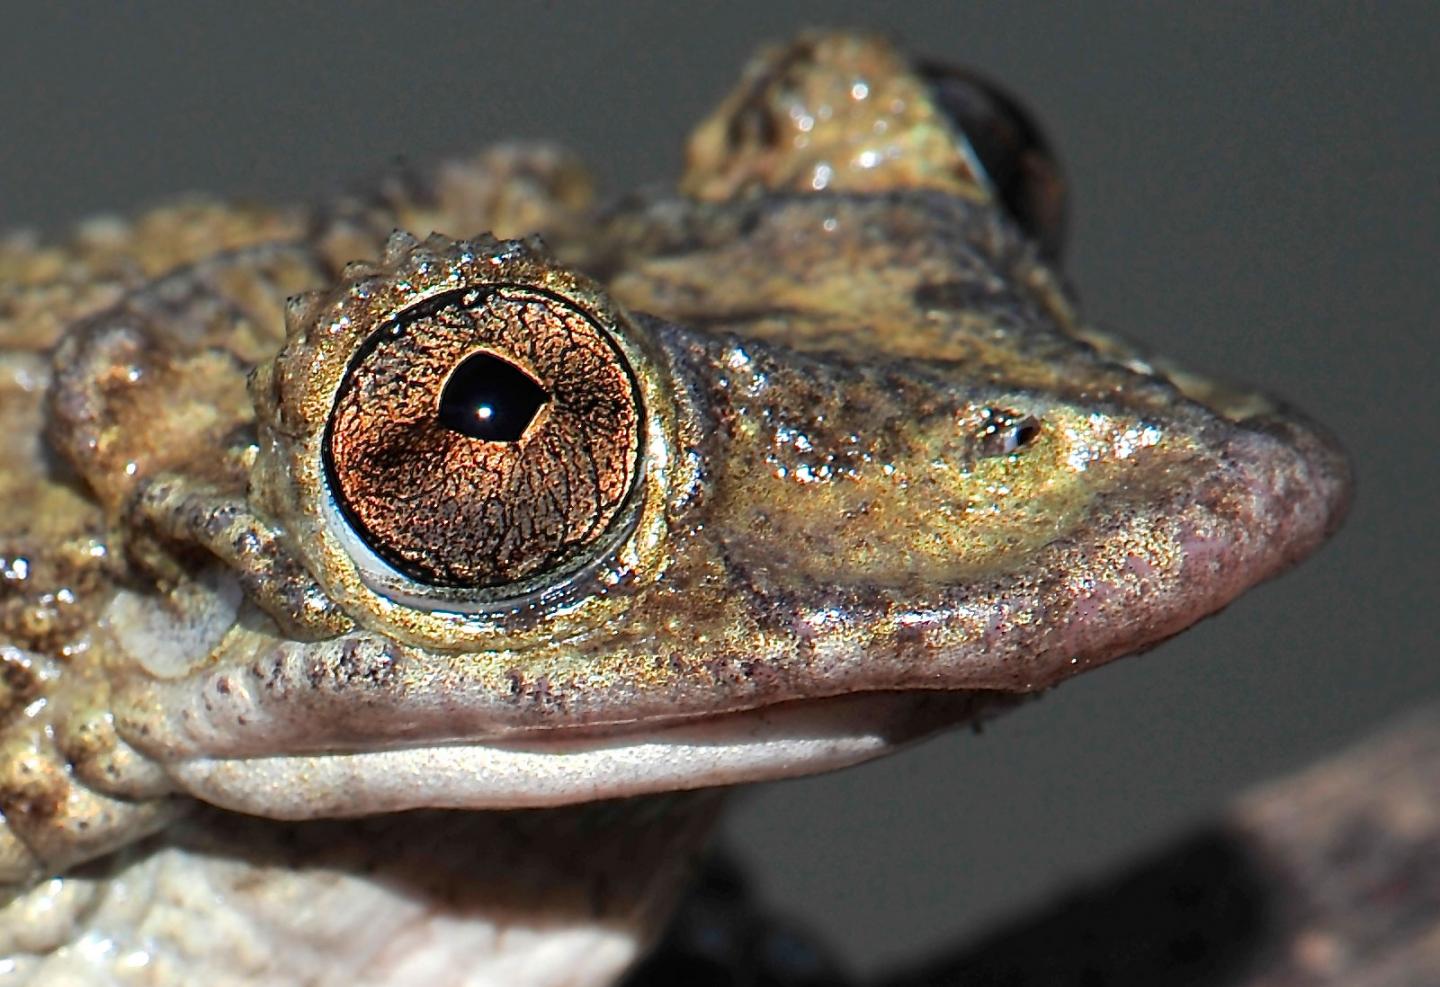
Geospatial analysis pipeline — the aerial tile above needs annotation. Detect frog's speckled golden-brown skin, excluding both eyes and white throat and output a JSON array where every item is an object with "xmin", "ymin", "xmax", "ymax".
[{"xmin": 0, "ymin": 36, "xmax": 1348, "ymax": 983}]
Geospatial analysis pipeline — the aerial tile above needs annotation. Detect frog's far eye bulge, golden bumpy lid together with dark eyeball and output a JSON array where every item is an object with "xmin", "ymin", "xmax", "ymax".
[{"xmin": 681, "ymin": 32, "xmax": 1066, "ymax": 259}]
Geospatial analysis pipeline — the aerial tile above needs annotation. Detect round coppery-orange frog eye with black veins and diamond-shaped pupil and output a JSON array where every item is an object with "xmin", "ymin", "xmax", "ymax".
[{"xmin": 321, "ymin": 284, "xmax": 642, "ymax": 598}]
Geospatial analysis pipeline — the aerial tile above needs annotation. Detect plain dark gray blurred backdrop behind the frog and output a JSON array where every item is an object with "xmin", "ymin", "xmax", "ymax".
[{"xmin": 0, "ymin": 0, "xmax": 1440, "ymax": 971}]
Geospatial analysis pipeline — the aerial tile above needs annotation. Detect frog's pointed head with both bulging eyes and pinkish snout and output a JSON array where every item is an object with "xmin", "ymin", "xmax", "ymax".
[{"xmin": 64, "ymin": 35, "xmax": 1348, "ymax": 818}]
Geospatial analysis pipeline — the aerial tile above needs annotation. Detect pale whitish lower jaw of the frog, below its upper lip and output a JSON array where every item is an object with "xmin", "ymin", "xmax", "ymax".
[{"xmin": 168, "ymin": 690, "xmax": 1025, "ymax": 820}]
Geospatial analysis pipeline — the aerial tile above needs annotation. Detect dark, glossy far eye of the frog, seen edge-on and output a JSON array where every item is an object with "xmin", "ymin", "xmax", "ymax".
[{"xmin": 917, "ymin": 62, "xmax": 1066, "ymax": 258}]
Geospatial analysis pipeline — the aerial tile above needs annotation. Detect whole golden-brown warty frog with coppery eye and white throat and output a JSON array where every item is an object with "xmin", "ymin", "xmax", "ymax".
[{"xmin": 0, "ymin": 30, "xmax": 1349, "ymax": 986}]
